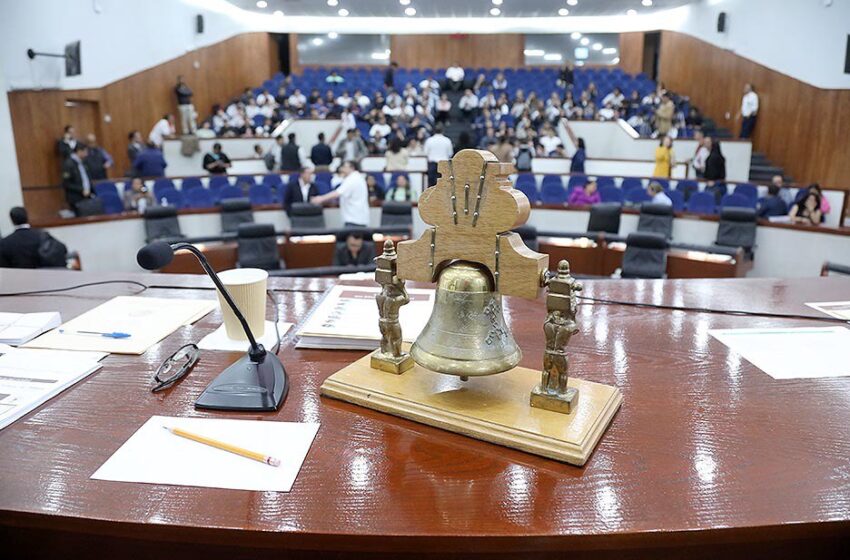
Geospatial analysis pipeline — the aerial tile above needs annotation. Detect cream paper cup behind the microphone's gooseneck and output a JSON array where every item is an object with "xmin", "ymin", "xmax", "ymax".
[{"xmin": 216, "ymin": 268, "xmax": 269, "ymax": 340}]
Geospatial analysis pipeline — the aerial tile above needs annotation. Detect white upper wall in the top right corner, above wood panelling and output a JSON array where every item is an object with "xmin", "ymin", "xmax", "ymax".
[{"xmin": 662, "ymin": 0, "xmax": 850, "ymax": 89}]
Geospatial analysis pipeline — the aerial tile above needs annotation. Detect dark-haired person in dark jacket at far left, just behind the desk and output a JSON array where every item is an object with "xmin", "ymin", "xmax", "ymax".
[{"xmin": 0, "ymin": 206, "xmax": 68, "ymax": 268}]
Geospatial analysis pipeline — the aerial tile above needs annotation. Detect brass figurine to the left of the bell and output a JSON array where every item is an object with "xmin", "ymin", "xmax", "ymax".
[{"xmin": 371, "ymin": 239, "xmax": 413, "ymax": 374}]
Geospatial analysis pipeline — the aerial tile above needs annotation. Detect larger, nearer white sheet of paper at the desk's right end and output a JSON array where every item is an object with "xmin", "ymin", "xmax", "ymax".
[{"xmin": 708, "ymin": 327, "xmax": 850, "ymax": 379}]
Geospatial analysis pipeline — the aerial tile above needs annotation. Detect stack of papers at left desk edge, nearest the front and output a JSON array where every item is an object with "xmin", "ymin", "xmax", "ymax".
[{"xmin": 0, "ymin": 346, "xmax": 106, "ymax": 428}]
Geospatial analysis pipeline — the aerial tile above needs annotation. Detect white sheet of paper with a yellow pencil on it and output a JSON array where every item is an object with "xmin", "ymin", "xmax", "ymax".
[{"xmin": 91, "ymin": 416, "xmax": 319, "ymax": 492}]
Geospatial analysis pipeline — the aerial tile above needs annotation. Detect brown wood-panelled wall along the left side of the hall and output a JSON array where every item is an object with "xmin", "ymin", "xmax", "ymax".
[{"xmin": 8, "ymin": 33, "xmax": 279, "ymax": 206}]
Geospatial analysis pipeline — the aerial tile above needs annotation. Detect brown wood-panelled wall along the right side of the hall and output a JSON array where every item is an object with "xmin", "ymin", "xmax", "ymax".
[{"xmin": 659, "ymin": 31, "xmax": 850, "ymax": 189}]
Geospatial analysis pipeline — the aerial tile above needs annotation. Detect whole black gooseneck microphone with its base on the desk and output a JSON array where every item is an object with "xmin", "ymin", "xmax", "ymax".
[{"xmin": 136, "ymin": 241, "xmax": 289, "ymax": 411}]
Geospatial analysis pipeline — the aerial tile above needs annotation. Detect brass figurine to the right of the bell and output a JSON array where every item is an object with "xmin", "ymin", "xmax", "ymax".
[{"xmin": 531, "ymin": 261, "xmax": 582, "ymax": 414}]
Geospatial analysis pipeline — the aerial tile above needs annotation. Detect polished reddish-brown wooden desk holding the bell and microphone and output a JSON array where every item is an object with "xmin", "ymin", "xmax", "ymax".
[{"xmin": 0, "ymin": 270, "xmax": 850, "ymax": 560}]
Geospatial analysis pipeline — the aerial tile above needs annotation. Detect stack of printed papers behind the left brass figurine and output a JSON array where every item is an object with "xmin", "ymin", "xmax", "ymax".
[{"xmin": 296, "ymin": 286, "xmax": 434, "ymax": 350}]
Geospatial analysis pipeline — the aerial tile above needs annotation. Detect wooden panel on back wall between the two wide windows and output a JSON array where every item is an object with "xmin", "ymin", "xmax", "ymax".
[{"xmin": 390, "ymin": 33, "xmax": 525, "ymax": 68}]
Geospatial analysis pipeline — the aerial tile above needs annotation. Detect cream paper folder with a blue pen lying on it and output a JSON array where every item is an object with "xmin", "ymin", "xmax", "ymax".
[{"xmin": 26, "ymin": 296, "xmax": 218, "ymax": 354}]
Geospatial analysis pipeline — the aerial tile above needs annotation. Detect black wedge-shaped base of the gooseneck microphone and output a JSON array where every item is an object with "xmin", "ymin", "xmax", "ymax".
[{"xmin": 195, "ymin": 353, "xmax": 289, "ymax": 412}]
